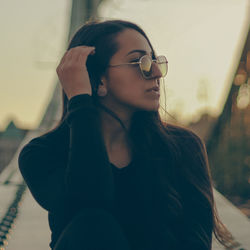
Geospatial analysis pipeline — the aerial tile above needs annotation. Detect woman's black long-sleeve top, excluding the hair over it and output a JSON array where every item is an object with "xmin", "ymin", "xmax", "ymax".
[{"xmin": 18, "ymin": 94, "xmax": 212, "ymax": 250}]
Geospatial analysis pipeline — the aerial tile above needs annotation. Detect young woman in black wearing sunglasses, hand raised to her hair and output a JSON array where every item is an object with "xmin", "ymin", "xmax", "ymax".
[{"xmin": 19, "ymin": 20, "xmax": 232, "ymax": 250}]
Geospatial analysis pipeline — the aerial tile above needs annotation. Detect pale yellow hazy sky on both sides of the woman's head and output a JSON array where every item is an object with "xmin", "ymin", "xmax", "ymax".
[{"xmin": 0, "ymin": 0, "xmax": 248, "ymax": 131}]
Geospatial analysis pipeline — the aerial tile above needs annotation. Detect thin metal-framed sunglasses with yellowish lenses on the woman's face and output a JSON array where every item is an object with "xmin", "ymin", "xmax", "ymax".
[{"xmin": 109, "ymin": 55, "xmax": 168, "ymax": 79}]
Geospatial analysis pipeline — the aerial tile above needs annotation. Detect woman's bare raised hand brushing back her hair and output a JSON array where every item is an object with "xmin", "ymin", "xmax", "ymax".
[{"xmin": 56, "ymin": 46, "xmax": 95, "ymax": 99}]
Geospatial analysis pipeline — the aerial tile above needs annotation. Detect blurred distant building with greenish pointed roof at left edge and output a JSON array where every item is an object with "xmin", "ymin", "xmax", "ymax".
[{"xmin": 0, "ymin": 121, "xmax": 28, "ymax": 173}]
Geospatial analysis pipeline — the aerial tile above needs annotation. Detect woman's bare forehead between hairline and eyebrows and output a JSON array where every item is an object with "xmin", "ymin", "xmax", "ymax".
[{"xmin": 114, "ymin": 29, "xmax": 152, "ymax": 57}]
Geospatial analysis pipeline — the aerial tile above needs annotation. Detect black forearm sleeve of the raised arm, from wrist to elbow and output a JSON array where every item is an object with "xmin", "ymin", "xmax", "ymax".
[{"xmin": 65, "ymin": 94, "xmax": 114, "ymax": 211}]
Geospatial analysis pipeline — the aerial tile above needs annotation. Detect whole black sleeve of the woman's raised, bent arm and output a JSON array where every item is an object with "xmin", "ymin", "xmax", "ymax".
[{"xmin": 18, "ymin": 94, "xmax": 114, "ymax": 212}]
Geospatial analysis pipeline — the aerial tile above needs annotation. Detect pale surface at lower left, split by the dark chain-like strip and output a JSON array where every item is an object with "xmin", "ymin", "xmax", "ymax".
[{"xmin": 0, "ymin": 132, "xmax": 50, "ymax": 250}]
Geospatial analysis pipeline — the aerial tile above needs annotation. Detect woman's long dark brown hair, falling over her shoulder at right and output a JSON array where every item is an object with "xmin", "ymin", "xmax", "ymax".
[{"xmin": 41, "ymin": 20, "xmax": 232, "ymax": 249}]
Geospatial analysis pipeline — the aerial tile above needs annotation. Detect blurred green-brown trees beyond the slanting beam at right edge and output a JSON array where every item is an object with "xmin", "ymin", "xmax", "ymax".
[{"xmin": 207, "ymin": 29, "xmax": 250, "ymax": 199}]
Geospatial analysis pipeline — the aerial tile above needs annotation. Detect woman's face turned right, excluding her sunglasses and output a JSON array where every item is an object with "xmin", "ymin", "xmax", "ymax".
[{"xmin": 102, "ymin": 29, "xmax": 161, "ymax": 115}]
